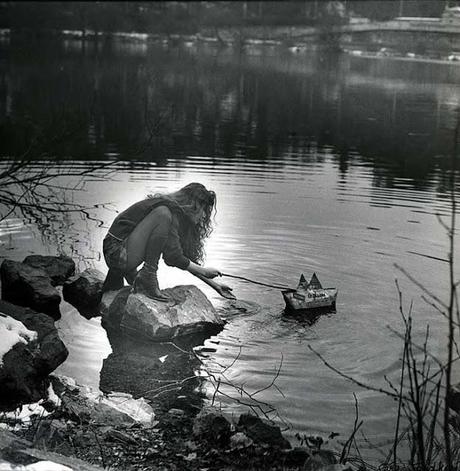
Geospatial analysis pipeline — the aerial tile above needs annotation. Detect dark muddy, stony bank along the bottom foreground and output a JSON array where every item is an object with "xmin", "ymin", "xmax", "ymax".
[{"xmin": 0, "ymin": 380, "xmax": 342, "ymax": 471}]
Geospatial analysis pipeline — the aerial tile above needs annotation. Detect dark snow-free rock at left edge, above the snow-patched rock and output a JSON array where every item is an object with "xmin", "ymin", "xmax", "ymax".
[{"xmin": 0, "ymin": 259, "xmax": 61, "ymax": 320}]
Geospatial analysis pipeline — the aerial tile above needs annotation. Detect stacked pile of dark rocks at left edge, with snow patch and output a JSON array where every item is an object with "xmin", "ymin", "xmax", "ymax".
[{"xmin": 0, "ymin": 255, "xmax": 75, "ymax": 410}]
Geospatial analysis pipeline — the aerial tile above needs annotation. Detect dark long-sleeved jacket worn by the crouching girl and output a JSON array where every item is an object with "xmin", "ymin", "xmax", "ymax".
[{"xmin": 109, "ymin": 196, "xmax": 190, "ymax": 270}]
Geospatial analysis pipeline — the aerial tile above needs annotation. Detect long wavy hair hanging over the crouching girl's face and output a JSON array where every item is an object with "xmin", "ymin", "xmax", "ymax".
[{"xmin": 148, "ymin": 183, "xmax": 216, "ymax": 263}]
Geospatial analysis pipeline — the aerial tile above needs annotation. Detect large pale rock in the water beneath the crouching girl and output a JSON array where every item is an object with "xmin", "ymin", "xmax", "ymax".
[{"xmin": 120, "ymin": 285, "xmax": 223, "ymax": 341}]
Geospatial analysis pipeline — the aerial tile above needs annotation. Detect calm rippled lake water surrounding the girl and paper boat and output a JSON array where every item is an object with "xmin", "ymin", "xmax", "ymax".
[{"xmin": 0, "ymin": 40, "xmax": 460, "ymax": 460}]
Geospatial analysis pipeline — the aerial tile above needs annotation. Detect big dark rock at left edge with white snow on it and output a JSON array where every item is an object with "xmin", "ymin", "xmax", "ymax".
[{"xmin": 0, "ymin": 301, "xmax": 68, "ymax": 410}]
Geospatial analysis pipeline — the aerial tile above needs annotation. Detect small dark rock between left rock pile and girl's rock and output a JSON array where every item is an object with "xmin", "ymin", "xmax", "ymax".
[{"xmin": 62, "ymin": 268, "xmax": 105, "ymax": 319}]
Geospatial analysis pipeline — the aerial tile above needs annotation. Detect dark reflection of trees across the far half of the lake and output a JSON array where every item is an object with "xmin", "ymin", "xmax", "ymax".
[{"xmin": 0, "ymin": 38, "xmax": 460, "ymax": 187}]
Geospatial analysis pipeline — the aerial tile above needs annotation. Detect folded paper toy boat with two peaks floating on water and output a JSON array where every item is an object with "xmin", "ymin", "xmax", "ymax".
[{"xmin": 282, "ymin": 273, "xmax": 338, "ymax": 312}]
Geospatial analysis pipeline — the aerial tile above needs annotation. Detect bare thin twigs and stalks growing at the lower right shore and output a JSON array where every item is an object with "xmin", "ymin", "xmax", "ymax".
[{"xmin": 309, "ymin": 111, "xmax": 460, "ymax": 471}]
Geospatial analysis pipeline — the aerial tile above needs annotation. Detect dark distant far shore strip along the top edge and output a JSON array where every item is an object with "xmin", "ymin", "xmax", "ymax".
[{"xmin": 0, "ymin": 0, "xmax": 455, "ymax": 34}]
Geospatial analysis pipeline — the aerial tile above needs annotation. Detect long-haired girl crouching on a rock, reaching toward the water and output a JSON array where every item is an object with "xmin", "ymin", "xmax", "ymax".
[{"xmin": 102, "ymin": 183, "xmax": 235, "ymax": 301}]
